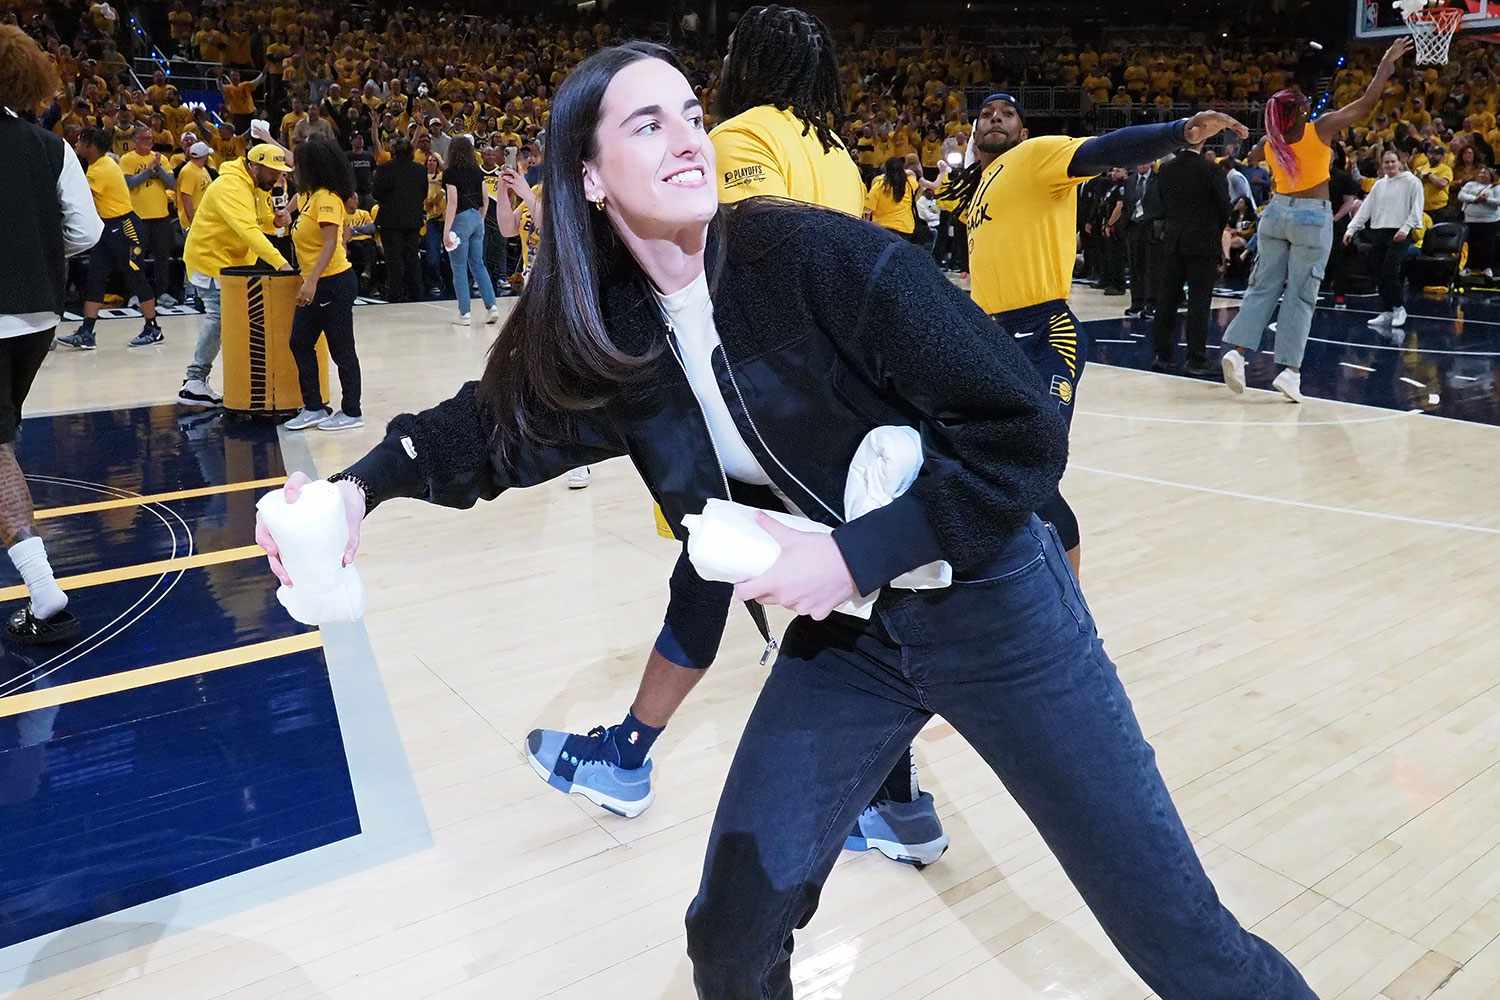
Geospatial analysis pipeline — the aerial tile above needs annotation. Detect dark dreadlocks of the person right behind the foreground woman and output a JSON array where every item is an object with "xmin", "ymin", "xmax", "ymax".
[{"xmin": 717, "ymin": 3, "xmax": 845, "ymax": 153}]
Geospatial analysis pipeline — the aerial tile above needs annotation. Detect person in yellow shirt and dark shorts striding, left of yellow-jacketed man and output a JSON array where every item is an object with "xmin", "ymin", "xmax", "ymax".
[{"xmin": 57, "ymin": 129, "xmax": 165, "ymax": 351}]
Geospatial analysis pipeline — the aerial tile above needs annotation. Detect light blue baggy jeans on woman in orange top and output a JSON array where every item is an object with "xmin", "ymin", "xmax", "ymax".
[{"xmin": 1224, "ymin": 195, "xmax": 1334, "ymax": 369}]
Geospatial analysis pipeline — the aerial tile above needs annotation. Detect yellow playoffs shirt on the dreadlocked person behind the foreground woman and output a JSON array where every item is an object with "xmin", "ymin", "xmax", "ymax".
[{"xmin": 710, "ymin": 105, "xmax": 864, "ymax": 216}]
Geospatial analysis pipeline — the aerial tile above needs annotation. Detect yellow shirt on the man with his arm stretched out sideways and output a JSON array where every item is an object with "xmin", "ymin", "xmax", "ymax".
[{"xmin": 965, "ymin": 135, "xmax": 1089, "ymax": 313}]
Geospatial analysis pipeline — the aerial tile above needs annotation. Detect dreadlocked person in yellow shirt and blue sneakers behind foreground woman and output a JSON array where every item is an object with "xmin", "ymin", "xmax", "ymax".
[{"xmin": 527, "ymin": 4, "xmax": 948, "ymax": 867}]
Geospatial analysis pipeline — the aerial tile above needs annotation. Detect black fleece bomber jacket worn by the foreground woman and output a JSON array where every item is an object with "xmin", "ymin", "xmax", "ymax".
[{"xmin": 350, "ymin": 199, "xmax": 1067, "ymax": 666}]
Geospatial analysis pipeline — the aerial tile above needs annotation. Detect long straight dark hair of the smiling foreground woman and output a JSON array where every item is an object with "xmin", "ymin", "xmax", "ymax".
[{"xmin": 477, "ymin": 42, "xmax": 693, "ymax": 454}]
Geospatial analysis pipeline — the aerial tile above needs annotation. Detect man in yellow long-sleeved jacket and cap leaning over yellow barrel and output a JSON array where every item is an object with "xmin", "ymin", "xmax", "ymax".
[{"xmin": 177, "ymin": 142, "xmax": 293, "ymax": 406}]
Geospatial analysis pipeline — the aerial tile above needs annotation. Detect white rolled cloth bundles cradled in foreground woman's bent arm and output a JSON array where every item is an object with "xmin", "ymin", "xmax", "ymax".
[{"xmin": 683, "ymin": 427, "xmax": 953, "ymax": 619}]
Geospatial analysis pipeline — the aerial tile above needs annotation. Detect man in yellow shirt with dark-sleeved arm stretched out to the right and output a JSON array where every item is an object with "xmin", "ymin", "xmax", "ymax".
[{"xmin": 941, "ymin": 93, "xmax": 1250, "ymax": 573}]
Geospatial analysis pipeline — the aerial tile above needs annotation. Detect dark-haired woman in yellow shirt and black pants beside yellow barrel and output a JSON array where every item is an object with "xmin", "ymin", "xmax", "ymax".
[{"xmin": 285, "ymin": 139, "xmax": 365, "ymax": 430}]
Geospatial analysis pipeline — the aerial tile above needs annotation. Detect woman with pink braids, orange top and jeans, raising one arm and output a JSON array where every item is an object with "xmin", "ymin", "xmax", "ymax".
[{"xmin": 1220, "ymin": 37, "xmax": 1412, "ymax": 403}]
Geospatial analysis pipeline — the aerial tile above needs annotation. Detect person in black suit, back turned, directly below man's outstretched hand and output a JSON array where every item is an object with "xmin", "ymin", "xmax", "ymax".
[{"xmin": 1151, "ymin": 142, "xmax": 1229, "ymax": 375}]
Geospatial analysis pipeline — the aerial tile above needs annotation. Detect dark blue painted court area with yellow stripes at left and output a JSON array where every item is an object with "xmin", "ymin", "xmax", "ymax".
[{"xmin": 0, "ymin": 406, "xmax": 360, "ymax": 948}]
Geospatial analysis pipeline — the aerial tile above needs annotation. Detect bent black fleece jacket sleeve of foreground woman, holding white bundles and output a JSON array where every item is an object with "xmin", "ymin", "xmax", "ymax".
[{"xmin": 809, "ymin": 241, "xmax": 1068, "ymax": 594}]
